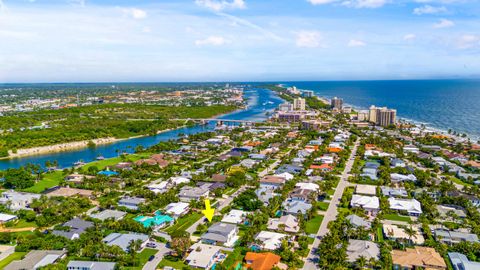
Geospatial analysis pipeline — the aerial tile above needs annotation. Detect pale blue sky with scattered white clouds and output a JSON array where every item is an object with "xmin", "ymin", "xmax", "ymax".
[{"xmin": 0, "ymin": 0, "xmax": 480, "ymax": 83}]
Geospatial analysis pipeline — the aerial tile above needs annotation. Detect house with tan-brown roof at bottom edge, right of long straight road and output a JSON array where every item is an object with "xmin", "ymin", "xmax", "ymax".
[{"xmin": 392, "ymin": 246, "xmax": 447, "ymax": 270}]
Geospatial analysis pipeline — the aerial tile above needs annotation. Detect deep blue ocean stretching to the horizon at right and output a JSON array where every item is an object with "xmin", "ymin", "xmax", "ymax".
[{"xmin": 282, "ymin": 80, "xmax": 480, "ymax": 140}]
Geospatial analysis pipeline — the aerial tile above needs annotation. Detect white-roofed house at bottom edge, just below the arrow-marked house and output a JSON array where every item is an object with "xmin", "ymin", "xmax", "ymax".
[{"xmin": 185, "ymin": 243, "xmax": 222, "ymax": 269}]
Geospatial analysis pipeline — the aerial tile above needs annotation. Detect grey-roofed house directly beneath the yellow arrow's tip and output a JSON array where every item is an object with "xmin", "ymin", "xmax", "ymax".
[{"xmin": 201, "ymin": 222, "xmax": 239, "ymax": 247}]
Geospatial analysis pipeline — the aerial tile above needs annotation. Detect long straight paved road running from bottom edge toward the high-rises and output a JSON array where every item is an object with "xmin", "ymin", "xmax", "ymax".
[{"xmin": 302, "ymin": 139, "xmax": 360, "ymax": 270}]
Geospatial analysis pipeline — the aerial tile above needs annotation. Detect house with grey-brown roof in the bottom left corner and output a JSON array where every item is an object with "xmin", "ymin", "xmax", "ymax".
[{"xmin": 3, "ymin": 250, "xmax": 67, "ymax": 270}]
